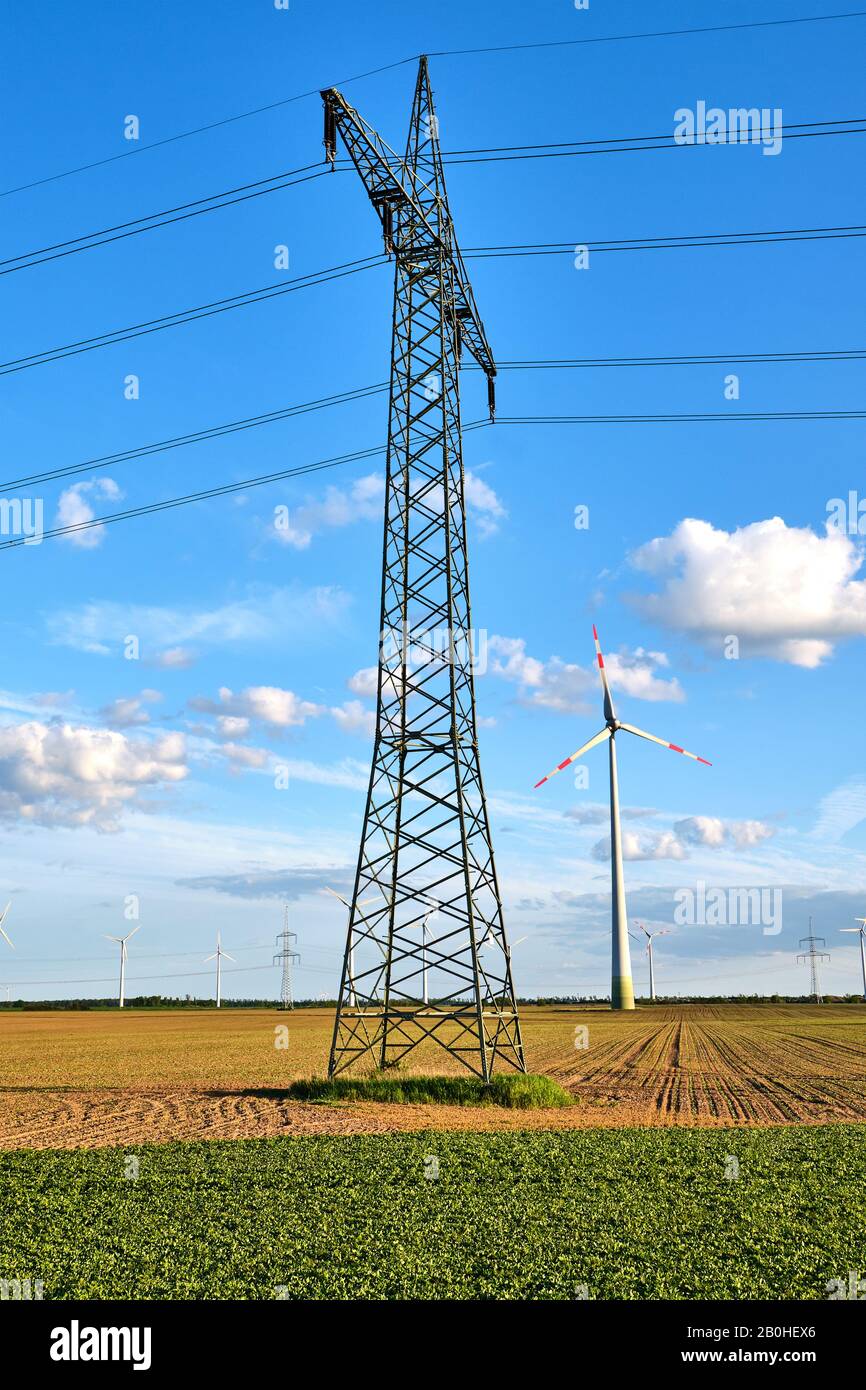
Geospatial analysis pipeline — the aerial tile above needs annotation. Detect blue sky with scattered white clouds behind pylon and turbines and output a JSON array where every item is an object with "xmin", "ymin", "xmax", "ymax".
[{"xmin": 0, "ymin": 0, "xmax": 866, "ymax": 997}]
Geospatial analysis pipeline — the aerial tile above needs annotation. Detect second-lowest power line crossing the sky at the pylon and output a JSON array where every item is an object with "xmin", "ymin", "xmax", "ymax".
[{"xmin": 0, "ymin": 348, "xmax": 866, "ymax": 493}]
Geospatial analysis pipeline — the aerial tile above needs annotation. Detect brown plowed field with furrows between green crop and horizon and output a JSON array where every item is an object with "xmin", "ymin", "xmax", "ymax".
[{"xmin": 0, "ymin": 1005, "xmax": 866, "ymax": 1148}]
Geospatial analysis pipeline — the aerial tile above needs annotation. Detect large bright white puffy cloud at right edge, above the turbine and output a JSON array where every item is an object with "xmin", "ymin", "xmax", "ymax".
[{"xmin": 631, "ymin": 517, "xmax": 866, "ymax": 667}]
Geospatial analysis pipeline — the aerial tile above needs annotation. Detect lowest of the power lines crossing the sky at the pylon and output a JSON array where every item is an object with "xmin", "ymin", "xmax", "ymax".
[{"xmin": 0, "ymin": 410, "xmax": 866, "ymax": 550}]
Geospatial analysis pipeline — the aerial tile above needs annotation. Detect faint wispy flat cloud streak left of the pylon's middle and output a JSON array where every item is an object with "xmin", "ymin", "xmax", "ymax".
[{"xmin": 46, "ymin": 585, "xmax": 350, "ymax": 666}]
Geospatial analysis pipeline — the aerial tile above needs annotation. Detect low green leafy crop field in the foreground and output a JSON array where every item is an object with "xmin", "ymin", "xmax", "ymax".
[{"xmin": 0, "ymin": 1125, "xmax": 866, "ymax": 1300}]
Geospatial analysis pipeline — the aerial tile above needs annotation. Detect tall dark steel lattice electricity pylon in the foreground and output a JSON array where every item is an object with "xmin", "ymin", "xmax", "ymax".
[{"xmin": 322, "ymin": 58, "xmax": 525, "ymax": 1081}]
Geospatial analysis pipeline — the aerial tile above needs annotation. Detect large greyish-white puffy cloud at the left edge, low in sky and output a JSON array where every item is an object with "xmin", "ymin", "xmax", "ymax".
[{"xmin": 0, "ymin": 720, "xmax": 188, "ymax": 830}]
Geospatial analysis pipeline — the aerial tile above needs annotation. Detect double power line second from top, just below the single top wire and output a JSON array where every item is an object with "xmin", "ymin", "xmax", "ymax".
[{"xmin": 0, "ymin": 115, "xmax": 866, "ymax": 275}]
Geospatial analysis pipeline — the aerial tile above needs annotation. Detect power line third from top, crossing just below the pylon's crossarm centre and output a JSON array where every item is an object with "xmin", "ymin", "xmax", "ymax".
[{"xmin": 0, "ymin": 224, "xmax": 866, "ymax": 377}]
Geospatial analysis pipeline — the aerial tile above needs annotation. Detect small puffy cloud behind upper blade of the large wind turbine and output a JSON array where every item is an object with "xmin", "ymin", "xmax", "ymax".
[{"xmin": 488, "ymin": 637, "xmax": 685, "ymax": 714}]
